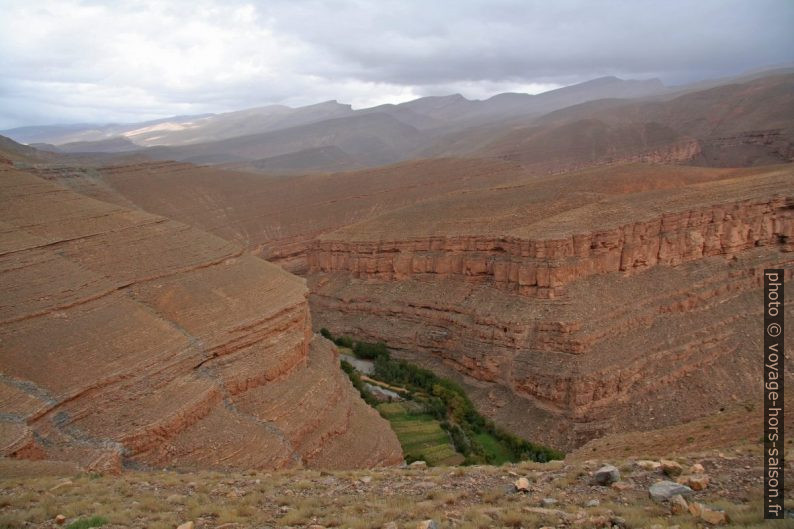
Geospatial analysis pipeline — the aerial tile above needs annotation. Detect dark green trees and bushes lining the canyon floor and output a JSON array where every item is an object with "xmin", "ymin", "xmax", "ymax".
[{"xmin": 320, "ymin": 329, "xmax": 564, "ymax": 465}]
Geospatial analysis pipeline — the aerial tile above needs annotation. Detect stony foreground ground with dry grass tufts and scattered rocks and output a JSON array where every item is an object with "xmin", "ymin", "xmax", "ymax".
[{"xmin": 0, "ymin": 444, "xmax": 794, "ymax": 529}]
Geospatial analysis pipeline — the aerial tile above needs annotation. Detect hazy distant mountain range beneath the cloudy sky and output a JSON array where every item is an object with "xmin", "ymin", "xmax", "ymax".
[{"xmin": 0, "ymin": 69, "xmax": 794, "ymax": 173}]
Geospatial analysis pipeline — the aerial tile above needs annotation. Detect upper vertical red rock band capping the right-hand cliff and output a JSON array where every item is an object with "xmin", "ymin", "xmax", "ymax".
[{"xmin": 308, "ymin": 174, "xmax": 794, "ymax": 298}]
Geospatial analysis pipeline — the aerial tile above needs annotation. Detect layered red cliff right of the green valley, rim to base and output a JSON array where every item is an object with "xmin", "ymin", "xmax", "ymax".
[{"xmin": 308, "ymin": 169, "xmax": 794, "ymax": 448}]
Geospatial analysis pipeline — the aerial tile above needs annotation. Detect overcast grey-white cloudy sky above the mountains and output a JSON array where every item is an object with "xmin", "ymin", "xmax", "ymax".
[{"xmin": 0, "ymin": 0, "xmax": 794, "ymax": 129}]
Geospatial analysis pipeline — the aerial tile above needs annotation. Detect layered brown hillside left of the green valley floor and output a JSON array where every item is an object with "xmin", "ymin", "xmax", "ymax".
[{"xmin": 0, "ymin": 167, "xmax": 402, "ymax": 471}]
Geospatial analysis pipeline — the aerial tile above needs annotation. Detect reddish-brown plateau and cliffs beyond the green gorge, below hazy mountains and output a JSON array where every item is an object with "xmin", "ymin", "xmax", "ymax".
[{"xmin": 24, "ymin": 155, "xmax": 794, "ymax": 450}]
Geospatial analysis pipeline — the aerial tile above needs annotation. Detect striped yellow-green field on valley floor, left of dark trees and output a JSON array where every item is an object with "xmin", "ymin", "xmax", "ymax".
[{"xmin": 377, "ymin": 402, "xmax": 464, "ymax": 466}]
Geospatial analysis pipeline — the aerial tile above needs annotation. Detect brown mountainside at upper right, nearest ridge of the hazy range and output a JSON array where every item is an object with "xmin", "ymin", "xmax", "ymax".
[{"xmin": 464, "ymin": 74, "xmax": 794, "ymax": 171}]
